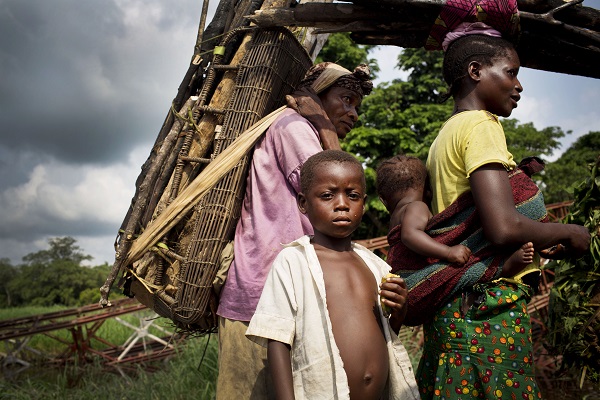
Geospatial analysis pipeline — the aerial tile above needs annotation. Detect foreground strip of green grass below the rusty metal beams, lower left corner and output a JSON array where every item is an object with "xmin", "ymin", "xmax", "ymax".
[{"xmin": 0, "ymin": 336, "xmax": 217, "ymax": 400}]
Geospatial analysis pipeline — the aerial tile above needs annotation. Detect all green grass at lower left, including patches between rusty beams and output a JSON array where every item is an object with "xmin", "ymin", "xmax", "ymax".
[{"xmin": 0, "ymin": 307, "xmax": 217, "ymax": 400}]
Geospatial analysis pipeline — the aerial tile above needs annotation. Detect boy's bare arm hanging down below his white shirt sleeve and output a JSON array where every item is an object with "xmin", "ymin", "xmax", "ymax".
[{"xmin": 267, "ymin": 340, "xmax": 294, "ymax": 400}]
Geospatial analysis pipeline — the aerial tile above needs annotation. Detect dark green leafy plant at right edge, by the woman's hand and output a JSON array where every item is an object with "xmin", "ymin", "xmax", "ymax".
[{"xmin": 547, "ymin": 154, "xmax": 600, "ymax": 382}]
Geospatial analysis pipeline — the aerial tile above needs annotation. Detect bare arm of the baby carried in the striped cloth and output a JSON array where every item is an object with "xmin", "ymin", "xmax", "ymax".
[{"xmin": 401, "ymin": 201, "xmax": 471, "ymax": 264}]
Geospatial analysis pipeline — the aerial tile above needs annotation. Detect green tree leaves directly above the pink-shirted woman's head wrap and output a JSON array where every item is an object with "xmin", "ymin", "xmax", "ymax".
[{"xmin": 315, "ymin": 32, "xmax": 379, "ymax": 79}]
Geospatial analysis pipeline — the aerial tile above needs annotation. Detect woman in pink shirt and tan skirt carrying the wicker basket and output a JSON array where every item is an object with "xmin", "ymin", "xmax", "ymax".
[{"xmin": 216, "ymin": 62, "xmax": 373, "ymax": 400}]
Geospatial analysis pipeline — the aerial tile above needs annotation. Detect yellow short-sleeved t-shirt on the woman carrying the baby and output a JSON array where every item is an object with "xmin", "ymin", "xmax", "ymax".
[{"xmin": 427, "ymin": 110, "xmax": 516, "ymax": 214}]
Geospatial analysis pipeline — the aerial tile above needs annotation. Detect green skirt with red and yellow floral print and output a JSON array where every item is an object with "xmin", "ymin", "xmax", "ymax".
[{"xmin": 417, "ymin": 280, "xmax": 542, "ymax": 400}]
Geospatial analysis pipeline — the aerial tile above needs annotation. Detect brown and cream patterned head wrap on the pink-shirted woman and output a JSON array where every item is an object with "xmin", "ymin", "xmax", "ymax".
[{"xmin": 298, "ymin": 62, "xmax": 373, "ymax": 97}]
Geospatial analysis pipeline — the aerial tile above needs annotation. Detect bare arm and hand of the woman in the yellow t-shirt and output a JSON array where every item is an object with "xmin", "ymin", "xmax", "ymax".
[{"xmin": 469, "ymin": 164, "xmax": 590, "ymax": 256}]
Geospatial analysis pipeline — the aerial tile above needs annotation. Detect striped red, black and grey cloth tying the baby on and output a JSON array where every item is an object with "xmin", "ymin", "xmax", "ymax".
[{"xmin": 387, "ymin": 157, "xmax": 548, "ymax": 326}]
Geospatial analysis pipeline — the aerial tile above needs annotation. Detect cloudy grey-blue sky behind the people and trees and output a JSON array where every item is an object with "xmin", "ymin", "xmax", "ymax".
[{"xmin": 0, "ymin": 0, "xmax": 600, "ymax": 265}]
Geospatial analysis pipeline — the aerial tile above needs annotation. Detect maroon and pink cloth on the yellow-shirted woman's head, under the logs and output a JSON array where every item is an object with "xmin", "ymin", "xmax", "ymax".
[{"xmin": 425, "ymin": 0, "xmax": 520, "ymax": 50}]
